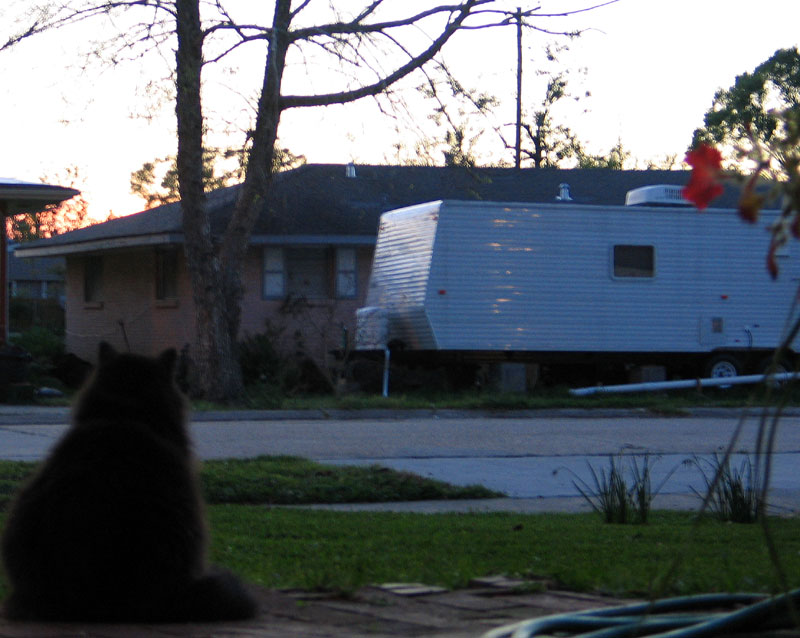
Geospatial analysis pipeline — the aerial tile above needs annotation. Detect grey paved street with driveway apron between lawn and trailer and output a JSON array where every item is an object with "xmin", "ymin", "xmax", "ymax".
[{"xmin": 0, "ymin": 410, "xmax": 800, "ymax": 512}]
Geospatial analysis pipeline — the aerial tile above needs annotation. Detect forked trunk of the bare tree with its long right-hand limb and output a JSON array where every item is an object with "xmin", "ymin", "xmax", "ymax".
[{"xmin": 175, "ymin": 0, "xmax": 482, "ymax": 400}]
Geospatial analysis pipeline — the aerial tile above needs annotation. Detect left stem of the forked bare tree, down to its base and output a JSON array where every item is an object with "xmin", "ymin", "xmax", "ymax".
[{"xmin": 176, "ymin": 0, "xmax": 242, "ymax": 400}]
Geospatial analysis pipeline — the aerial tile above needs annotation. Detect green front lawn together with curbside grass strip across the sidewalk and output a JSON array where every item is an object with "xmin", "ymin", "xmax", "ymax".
[{"xmin": 0, "ymin": 457, "xmax": 800, "ymax": 597}]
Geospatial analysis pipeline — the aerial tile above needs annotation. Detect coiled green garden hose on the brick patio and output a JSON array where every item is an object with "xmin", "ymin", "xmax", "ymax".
[{"xmin": 484, "ymin": 589, "xmax": 800, "ymax": 638}]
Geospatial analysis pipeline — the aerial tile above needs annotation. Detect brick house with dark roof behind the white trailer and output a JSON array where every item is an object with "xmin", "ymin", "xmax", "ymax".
[{"xmin": 16, "ymin": 164, "xmax": 734, "ymax": 376}]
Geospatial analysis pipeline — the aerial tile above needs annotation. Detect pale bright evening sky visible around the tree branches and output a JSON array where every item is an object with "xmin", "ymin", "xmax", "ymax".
[{"xmin": 0, "ymin": 0, "xmax": 800, "ymax": 218}]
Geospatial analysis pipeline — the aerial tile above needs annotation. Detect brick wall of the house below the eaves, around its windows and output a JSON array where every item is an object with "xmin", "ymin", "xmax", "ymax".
[{"xmin": 66, "ymin": 247, "xmax": 373, "ymax": 366}]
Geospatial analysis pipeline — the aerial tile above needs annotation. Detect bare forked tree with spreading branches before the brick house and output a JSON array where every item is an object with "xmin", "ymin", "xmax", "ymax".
[{"xmin": 0, "ymin": 0, "xmax": 616, "ymax": 400}]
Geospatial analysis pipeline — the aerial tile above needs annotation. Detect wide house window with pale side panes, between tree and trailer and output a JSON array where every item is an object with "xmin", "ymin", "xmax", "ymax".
[{"xmin": 263, "ymin": 246, "xmax": 356, "ymax": 299}]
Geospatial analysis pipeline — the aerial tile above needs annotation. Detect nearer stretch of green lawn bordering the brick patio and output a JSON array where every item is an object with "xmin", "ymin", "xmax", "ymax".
[{"xmin": 0, "ymin": 505, "xmax": 800, "ymax": 596}]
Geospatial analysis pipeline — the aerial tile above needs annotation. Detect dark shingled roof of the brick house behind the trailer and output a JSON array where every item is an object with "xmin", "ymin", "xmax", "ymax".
[{"xmin": 17, "ymin": 164, "xmax": 752, "ymax": 257}]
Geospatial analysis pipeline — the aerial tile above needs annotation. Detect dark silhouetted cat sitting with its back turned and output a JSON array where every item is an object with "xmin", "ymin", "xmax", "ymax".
[{"xmin": 2, "ymin": 343, "xmax": 256, "ymax": 622}]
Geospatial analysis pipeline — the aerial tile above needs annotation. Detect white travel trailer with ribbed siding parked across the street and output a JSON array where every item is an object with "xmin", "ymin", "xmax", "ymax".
[{"xmin": 356, "ymin": 186, "xmax": 800, "ymax": 388}]
